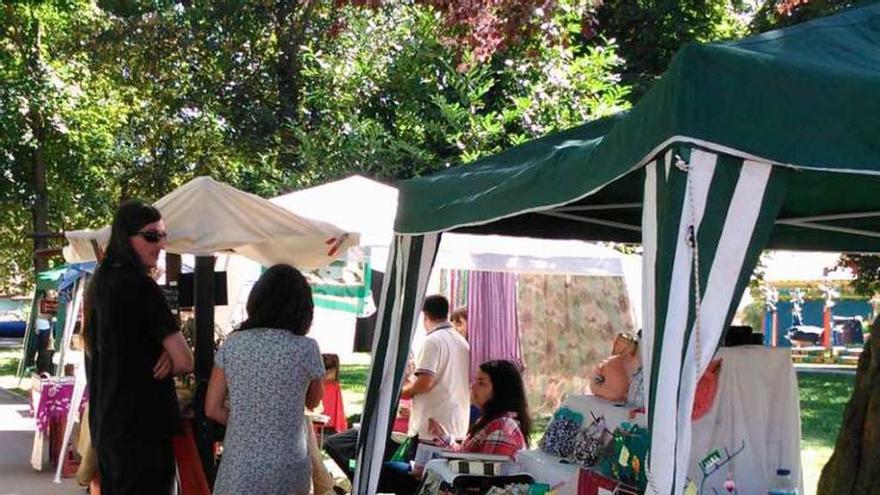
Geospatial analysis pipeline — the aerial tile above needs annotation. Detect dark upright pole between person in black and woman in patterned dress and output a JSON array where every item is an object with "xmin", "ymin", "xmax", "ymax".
[{"xmin": 193, "ymin": 256, "xmax": 216, "ymax": 488}]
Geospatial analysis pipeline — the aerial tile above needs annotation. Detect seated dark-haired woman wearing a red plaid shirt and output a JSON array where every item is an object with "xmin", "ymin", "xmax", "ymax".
[{"xmin": 428, "ymin": 361, "xmax": 532, "ymax": 458}]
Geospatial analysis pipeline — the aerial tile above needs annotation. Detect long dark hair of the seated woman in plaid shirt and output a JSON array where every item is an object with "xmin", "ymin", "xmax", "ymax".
[{"xmin": 468, "ymin": 359, "xmax": 532, "ymax": 445}]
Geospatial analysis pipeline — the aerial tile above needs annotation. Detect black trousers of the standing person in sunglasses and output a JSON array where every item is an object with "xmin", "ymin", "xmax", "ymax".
[{"xmin": 96, "ymin": 438, "xmax": 174, "ymax": 495}]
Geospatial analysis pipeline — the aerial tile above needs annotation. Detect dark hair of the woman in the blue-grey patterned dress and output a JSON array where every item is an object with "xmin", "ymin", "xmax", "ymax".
[{"xmin": 238, "ymin": 265, "xmax": 315, "ymax": 335}]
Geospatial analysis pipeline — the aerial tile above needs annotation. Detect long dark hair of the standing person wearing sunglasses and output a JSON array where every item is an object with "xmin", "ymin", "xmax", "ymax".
[{"xmin": 102, "ymin": 199, "xmax": 162, "ymax": 270}]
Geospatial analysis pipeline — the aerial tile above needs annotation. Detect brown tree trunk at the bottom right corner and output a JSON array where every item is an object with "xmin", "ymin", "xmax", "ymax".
[{"xmin": 816, "ymin": 317, "xmax": 880, "ymax": 495}]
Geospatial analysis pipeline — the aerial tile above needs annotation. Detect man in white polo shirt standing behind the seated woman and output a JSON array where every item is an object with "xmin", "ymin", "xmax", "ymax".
[{"xmin": 400, "ymin": 295, "xmax": 470, "ymax": 441}]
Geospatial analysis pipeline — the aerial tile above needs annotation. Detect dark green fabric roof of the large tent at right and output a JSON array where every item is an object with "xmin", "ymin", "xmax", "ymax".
[{"xmin": 395, "ymin": 1, "xmax": 880, "ymax": 251}]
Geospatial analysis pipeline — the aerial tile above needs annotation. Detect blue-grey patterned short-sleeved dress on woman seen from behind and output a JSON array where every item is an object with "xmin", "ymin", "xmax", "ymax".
[{"xmin": 214, "ymin": 328, "xmax": 324, "ymax": 495}]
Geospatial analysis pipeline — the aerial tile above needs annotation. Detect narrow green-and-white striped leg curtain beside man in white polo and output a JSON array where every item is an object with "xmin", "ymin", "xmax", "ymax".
[{"xmin": 353, "ymin": 234, "xmax": 440, "ymax": 495}]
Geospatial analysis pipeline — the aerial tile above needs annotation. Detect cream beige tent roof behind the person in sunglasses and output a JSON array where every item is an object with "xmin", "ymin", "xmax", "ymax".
[{"xmin": 64, "ymin": 177, "xmax": 358, "ymax": 268}]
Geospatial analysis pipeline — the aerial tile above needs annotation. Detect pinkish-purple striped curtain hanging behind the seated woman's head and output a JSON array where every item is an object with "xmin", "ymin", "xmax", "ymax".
[{"xmin": 467, "ymin": 271, "xmax": 522, "ymax": 380}]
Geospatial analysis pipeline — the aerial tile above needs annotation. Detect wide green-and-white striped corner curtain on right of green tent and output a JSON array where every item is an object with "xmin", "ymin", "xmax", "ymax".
[{"xmin": 642, "ymin": 148, "xmax": 799, "ymax": 494}]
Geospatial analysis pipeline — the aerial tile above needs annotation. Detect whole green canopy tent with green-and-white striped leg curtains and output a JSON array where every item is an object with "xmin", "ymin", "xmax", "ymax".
[{"xmin": 355, "ymin": 2, "xmax": 880, "ymax": 494}]
